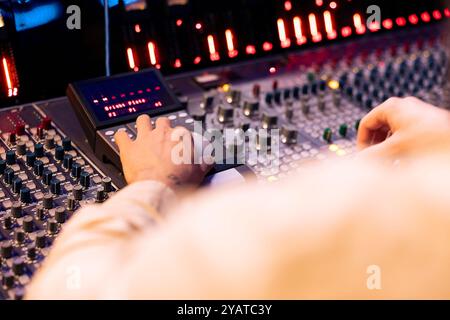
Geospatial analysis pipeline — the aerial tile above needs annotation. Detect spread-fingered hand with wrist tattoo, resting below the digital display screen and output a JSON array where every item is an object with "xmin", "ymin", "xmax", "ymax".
[{"xmin": 115, "ymin": 115, "xmax": 210, "ymax": 191}]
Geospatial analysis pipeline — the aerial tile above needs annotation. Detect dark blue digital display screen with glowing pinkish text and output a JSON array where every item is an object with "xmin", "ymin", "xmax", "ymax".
[{"xmin": 77, "ymin": 70, "xmax": 179, "ymax": 122}]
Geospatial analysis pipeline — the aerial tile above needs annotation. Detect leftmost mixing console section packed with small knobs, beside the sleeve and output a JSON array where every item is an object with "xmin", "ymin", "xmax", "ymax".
[{"xmin": 0, "ymin": 106, "xmax": 116, "ymax": 299}]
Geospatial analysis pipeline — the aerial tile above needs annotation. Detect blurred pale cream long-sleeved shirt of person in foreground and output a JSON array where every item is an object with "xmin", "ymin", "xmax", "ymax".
[{"xmin": 27, "ymin": 156, "xmax": 450, "ymax": 299}]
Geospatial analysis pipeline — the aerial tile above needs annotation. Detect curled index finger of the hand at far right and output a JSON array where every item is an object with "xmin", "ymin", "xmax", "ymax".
[{"xmin": 357, "ymin": 98, "xmax": 401, "ymax": 149}]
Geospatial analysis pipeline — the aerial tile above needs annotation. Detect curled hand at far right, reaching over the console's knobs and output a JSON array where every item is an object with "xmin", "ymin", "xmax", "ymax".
[{"xmin": 358, "ymin": 97, "xmax": 450, "ymax": 159}]
